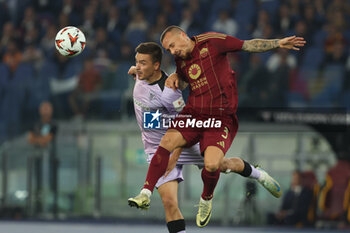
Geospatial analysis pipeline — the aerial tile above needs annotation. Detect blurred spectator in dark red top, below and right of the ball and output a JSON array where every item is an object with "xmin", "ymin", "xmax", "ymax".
[{"xmin": 69, "ymin": 58, "xmax": 102, "ymax": 116}]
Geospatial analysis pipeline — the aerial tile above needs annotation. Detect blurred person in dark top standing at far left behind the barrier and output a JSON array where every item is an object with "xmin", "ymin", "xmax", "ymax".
[{"xmin": 28, "ymin": 101, "xmax": 57, "ymax": 147}]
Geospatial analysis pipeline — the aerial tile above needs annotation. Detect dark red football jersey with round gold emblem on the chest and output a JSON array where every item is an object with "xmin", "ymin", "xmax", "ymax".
[{"xmin": 175, "ymin": 32, "xmax": 243, "ymax": 115}]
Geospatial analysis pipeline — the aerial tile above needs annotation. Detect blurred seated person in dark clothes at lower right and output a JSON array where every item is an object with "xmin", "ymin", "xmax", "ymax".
[{"xmin": 268, "ymin": 171, "xmax": 312, "ymax": 226}]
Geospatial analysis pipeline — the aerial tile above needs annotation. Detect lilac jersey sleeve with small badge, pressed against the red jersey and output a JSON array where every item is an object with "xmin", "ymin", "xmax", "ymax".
[{"xmin": 161, "ymin": 87, "xmax": 185, "ymax": 114}]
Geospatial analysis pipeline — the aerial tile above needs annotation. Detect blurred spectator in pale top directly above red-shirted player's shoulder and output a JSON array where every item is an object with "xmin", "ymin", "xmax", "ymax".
[{"xmin": 212, "ymin": 10, "xmax": 238, "ymax": 36}]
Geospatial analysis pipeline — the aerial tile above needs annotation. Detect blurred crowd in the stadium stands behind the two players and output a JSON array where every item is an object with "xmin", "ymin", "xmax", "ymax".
[{"xmin": 0, "ymin": 0, "xmax": 350, "ymax": 143}]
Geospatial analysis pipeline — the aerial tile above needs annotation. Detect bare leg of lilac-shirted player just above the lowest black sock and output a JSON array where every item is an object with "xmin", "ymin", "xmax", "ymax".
[{"xmin": 158, "ymin": 180, "xmax": 179, "ymax": 209}]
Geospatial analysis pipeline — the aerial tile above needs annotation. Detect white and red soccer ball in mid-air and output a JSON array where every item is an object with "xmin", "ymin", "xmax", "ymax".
[{"xmin": 55, "ymin": 26, "xmax": 86, "ymax": 57}]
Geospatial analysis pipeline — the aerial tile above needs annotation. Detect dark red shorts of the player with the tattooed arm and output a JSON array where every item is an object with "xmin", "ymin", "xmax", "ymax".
[{"xmin": 169, "ymin": 107, "xmax": 238, "ymax": 154}]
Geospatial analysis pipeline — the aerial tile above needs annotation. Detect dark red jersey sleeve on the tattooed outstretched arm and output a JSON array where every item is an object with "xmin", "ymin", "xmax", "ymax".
[{"xmin": 210, "ymin": 33, "xmax": 244, "ymax": 53}]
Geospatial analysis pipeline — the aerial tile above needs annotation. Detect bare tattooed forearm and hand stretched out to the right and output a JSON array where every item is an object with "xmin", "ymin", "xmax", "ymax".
[{"xmin": 242, "ymin": 36, "xmax": 306, "ymax": 53}]
